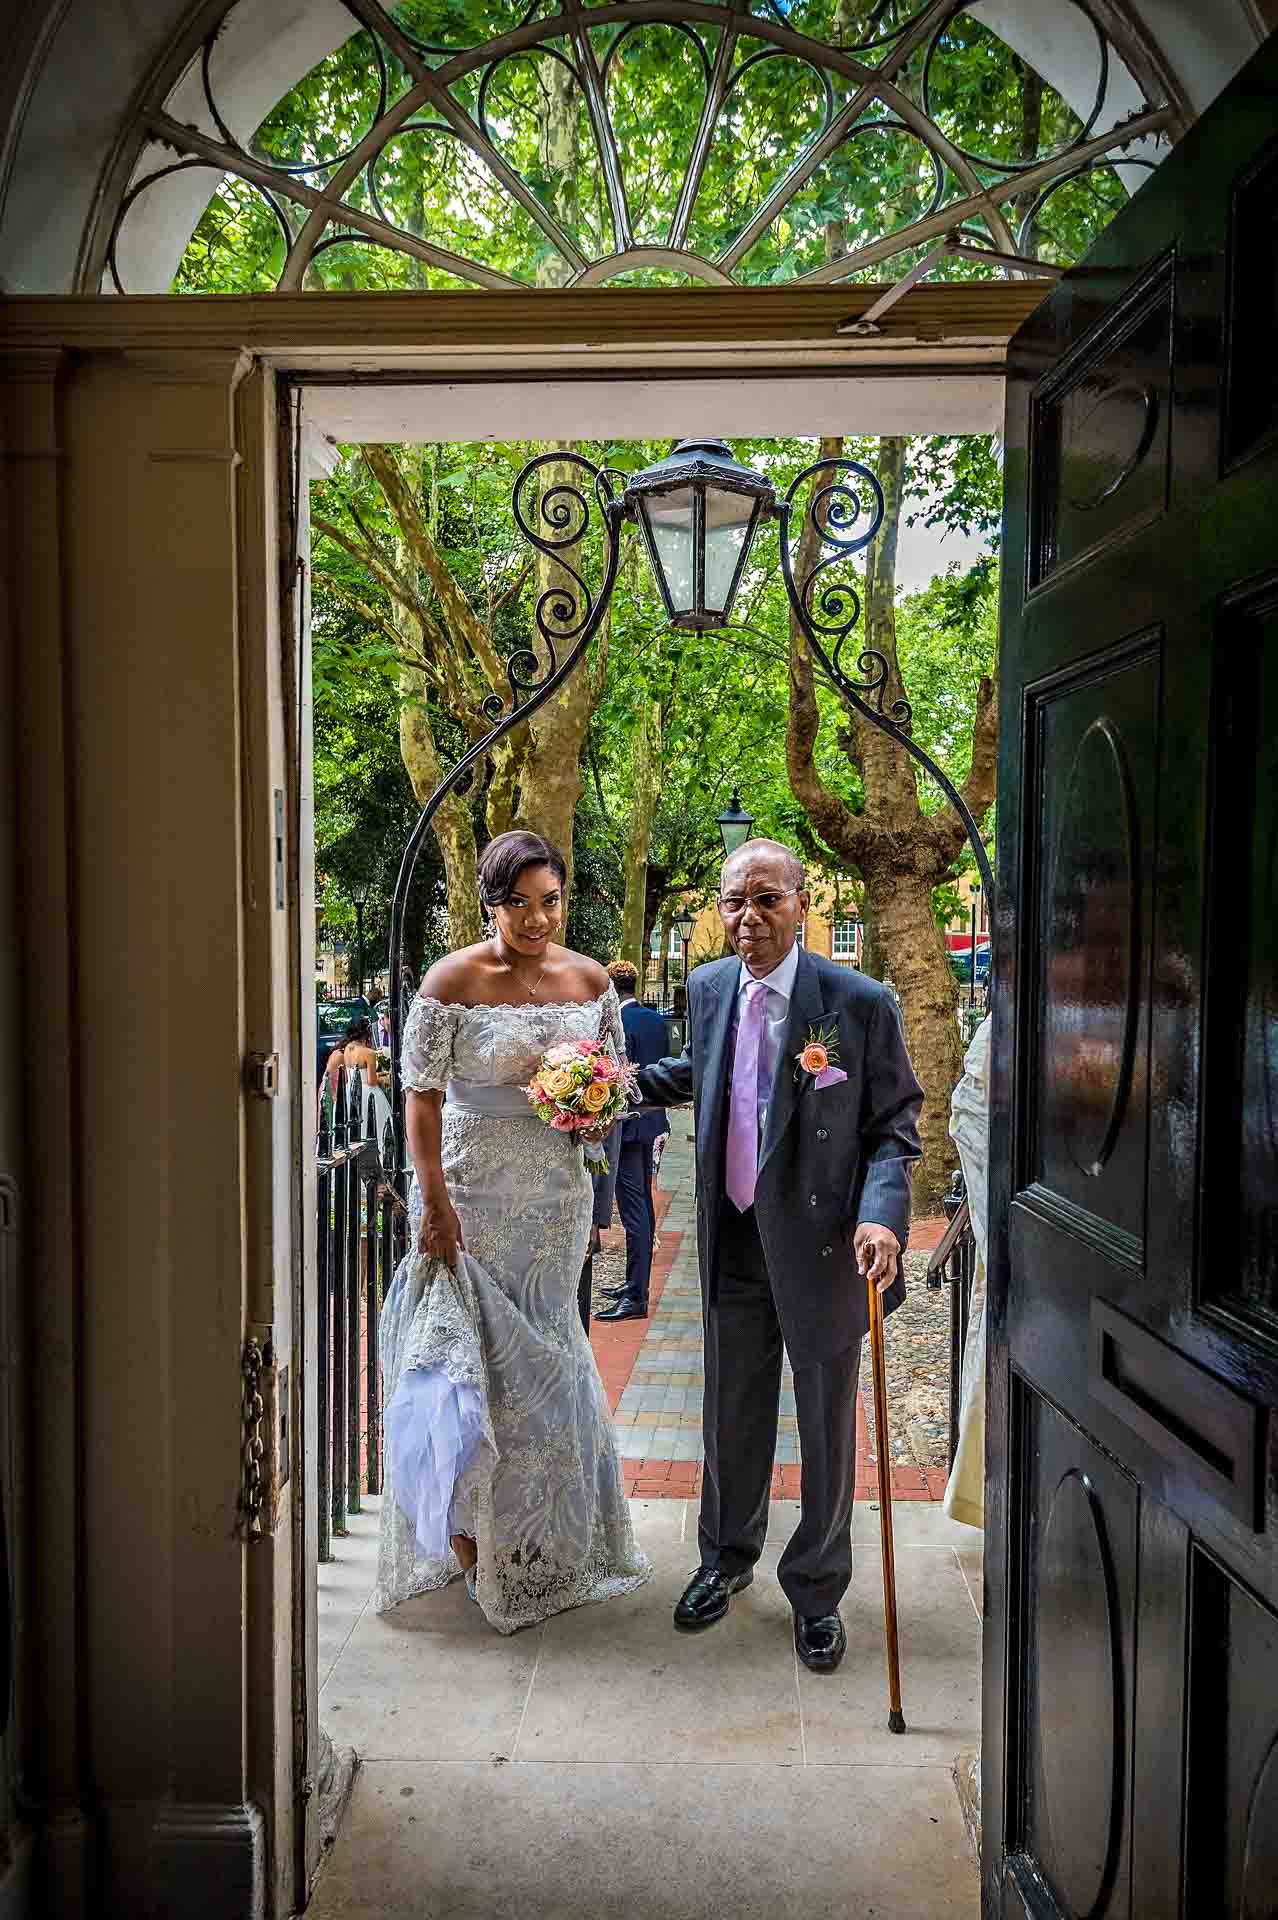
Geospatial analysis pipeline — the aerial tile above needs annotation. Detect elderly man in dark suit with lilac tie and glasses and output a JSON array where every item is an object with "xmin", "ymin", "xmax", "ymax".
[{"xmin": 637, "ymin": 839, "xmax": 923, "ymax": 1672}]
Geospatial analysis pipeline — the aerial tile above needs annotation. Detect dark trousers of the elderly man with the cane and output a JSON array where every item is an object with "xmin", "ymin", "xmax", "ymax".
[{"xmin": 698, "ymin": 1200, "xmax": 862, "ymax": 1615}]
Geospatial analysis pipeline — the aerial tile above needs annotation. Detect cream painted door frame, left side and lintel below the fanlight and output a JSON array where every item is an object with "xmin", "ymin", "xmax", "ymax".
[{"xmin": 0, "ymin": 284, "xmax": 1042, "ymax": 1920}]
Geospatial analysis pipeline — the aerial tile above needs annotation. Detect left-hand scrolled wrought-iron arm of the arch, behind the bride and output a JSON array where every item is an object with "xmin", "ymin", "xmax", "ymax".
[{"xmin": 390, "ymin": 451, "xmax": 622, "ymax": 1183}]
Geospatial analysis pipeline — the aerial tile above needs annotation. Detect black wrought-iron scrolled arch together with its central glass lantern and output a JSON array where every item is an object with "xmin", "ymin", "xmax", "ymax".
[{"xmin": 390, "ymin": 440, "xmax": 994, "ymax": 1190}]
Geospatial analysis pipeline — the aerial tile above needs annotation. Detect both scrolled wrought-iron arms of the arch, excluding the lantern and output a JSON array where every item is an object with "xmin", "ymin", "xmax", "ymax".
[{"xmin": 390, "ymin": 444, "xmax": 994, "ymax": 1183}]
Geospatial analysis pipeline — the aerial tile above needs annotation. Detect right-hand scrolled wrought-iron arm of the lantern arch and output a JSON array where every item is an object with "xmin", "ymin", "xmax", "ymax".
[{"xmin": 777, "ymin": 459, "xmax": 994, "ymax": 902}]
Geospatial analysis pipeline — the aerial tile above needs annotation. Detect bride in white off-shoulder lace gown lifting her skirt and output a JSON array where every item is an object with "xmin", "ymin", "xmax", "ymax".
[{"xmin": 376, "ymin": 833, "xmax": 649, "ymax": 1634}]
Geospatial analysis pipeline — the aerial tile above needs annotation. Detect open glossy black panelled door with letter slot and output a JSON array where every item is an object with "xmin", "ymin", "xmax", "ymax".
[{"xmin": 982, "ymin": 30, "xmax": 1278, "ymax": 1920}]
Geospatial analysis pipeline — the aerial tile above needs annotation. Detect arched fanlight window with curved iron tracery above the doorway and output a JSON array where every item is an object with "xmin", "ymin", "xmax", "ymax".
[{"xmin": 88, "ymin": 0, "xmax": 1176, "ymax": 292}]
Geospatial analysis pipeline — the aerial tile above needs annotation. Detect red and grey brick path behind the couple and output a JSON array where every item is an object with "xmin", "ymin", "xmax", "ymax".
[{"xmin": 591, "ymin": 1116, "xmax": 946, "ymax": 1501}]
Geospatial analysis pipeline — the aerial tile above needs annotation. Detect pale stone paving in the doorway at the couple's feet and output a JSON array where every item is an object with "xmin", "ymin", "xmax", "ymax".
[{"xmin": 307, "ymin": 1498, "xmax": 979, "ymax": 1920}]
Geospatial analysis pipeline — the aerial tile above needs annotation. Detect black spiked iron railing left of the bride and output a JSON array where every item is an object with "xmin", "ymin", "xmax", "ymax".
[{"xmin": 315, "ymin": 1068, "xmax": 409, "ymax": 1561}]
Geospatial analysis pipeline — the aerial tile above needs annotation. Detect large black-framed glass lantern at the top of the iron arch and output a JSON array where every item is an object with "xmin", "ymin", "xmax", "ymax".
[{"xmin": 622, "ymin": 440, "xmax": 777, "ymax": 632}]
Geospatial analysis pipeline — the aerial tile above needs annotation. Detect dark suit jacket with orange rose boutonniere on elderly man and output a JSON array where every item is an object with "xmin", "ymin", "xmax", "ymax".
[{"xmin": 639, "ymin": 948, "xmax": 923, "ymax": 1367}]
